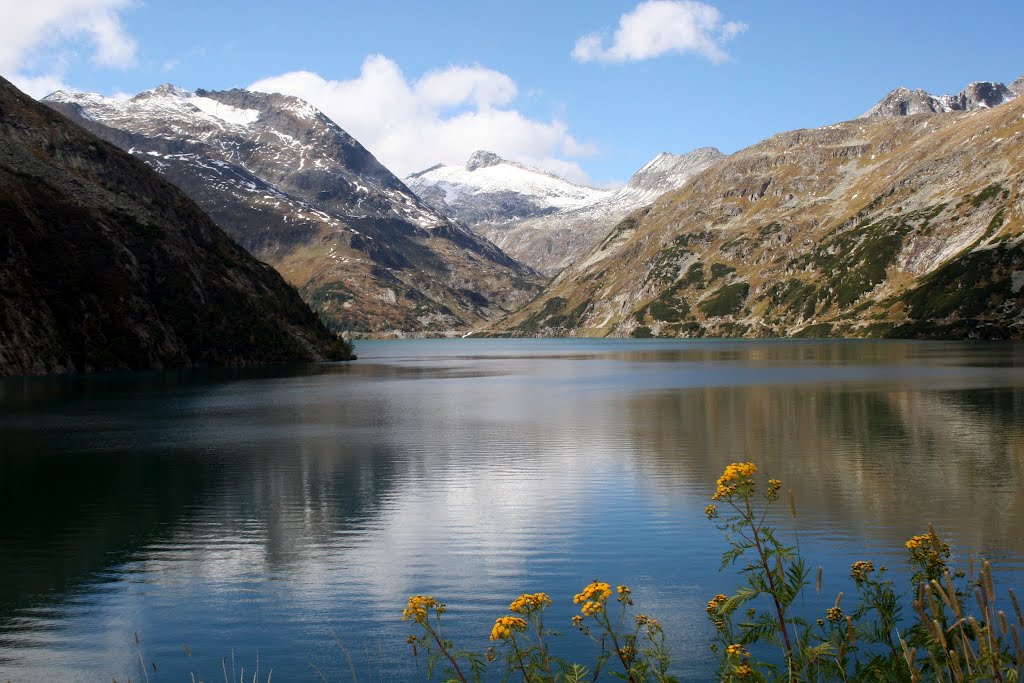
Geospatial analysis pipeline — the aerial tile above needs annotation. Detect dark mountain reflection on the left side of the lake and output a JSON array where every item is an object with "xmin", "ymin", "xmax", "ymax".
[{"xmin": 0, "ymin": 366, "xmax": 407, "ymax": 633}]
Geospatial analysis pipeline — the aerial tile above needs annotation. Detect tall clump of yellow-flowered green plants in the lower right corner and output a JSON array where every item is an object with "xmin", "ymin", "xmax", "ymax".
[{"xmin": 705, "ymin": 463, "xmax": 1024, "ymax": 683}]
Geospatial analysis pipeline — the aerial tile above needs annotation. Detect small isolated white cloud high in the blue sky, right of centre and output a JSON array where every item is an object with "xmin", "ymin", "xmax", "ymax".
[{"xmin": 572, "ymin": 0, "xmax": 746, "ymax": 63}]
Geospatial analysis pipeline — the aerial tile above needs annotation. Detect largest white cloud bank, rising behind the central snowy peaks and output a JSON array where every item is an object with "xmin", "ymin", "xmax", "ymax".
[{"xmin": 249, "ymin": 54, "xmax": 594, "ymax": 182}]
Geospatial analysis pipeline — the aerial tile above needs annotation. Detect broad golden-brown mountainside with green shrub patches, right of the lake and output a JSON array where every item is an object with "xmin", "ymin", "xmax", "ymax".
[{"xmin": 493, "ymin": 93, "xmax": 1024, "ymax": 339}]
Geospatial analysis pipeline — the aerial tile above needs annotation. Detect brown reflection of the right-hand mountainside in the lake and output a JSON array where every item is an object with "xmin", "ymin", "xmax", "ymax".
[{"xmin": 628, "ymin": 384, "xmax": 1024, "ymax": 553}]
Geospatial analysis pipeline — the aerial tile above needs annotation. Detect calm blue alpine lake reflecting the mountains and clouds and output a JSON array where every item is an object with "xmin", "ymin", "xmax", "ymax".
[{"xmin": 0, "ymin": 340, "xmax": 1024, "ymax": 681}]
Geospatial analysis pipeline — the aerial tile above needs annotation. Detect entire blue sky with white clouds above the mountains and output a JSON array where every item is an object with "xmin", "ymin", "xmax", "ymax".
[{"xmin": 0, "ymin": 0, "xmax": 1024, "ymax": 184}]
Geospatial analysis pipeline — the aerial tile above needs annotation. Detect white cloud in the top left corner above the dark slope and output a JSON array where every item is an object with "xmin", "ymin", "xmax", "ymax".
[{"xmin": 0, "ymin": 0, "xmax": 136, "ymax": 96}]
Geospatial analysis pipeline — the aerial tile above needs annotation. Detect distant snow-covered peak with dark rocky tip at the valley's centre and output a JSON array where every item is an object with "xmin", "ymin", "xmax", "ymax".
[{"xmin": 406, "ymin": 151, "xmax": 611, "ymax": 226}]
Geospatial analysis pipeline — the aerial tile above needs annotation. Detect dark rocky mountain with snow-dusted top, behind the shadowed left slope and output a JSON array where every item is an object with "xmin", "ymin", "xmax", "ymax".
[{"xmin": 43, "ymin": 84, "xmax": 541, "ymax": 333}]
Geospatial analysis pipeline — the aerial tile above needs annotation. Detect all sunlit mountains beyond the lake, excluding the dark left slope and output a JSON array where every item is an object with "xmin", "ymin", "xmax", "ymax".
[{"xmin": 32, "ymin": 74, "xmax": 1024, "ymax": 338}]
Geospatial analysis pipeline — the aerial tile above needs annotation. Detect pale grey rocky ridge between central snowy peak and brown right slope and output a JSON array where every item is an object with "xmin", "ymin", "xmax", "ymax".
[{"xmin": 474, "ymin": 147, "xmax": 725, "ymax": 275}]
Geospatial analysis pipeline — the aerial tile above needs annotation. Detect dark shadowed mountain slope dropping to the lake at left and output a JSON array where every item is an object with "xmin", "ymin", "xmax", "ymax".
[{"xmin": 0, "ymin": 79, "xmax": 348, "ymax": 375}]
